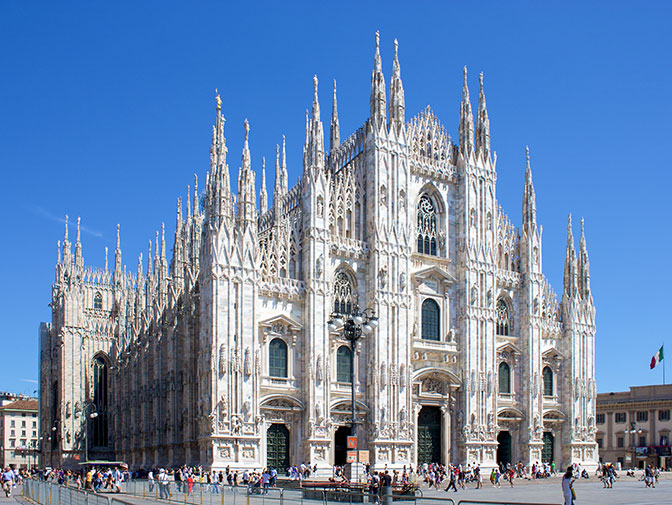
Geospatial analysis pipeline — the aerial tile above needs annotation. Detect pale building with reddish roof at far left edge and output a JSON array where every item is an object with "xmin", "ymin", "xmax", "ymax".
[{"xmin": 0, "ymin": 397, "xmax": 40, "ymax": 469}]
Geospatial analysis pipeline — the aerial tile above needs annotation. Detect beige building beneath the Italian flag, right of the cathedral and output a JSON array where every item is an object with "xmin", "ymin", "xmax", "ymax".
[{"xmin": 596, "ymin": 384, "xmax": 672, "ymax": 469}]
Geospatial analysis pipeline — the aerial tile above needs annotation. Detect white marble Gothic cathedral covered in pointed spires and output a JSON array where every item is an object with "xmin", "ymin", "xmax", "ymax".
[{"xmin": 40, "ymin": 34, "xmax": 598, "ymax": 475}]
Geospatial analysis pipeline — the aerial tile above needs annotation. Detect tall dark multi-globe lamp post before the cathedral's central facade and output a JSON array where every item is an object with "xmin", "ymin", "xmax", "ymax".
[{"xmin": 327, "ymin": 306, "xmax": 378, "ymax": 481}]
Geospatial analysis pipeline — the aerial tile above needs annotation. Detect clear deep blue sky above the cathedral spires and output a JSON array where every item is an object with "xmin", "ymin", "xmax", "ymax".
[{"xmin": 0, "ymin": 1, "xmax": 672, "ymax": 393}]
